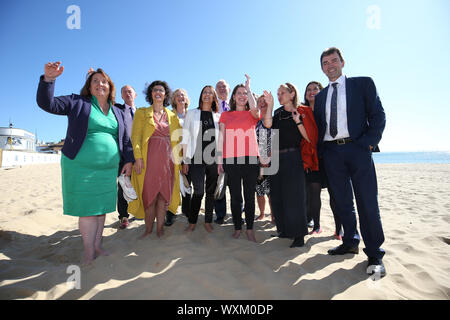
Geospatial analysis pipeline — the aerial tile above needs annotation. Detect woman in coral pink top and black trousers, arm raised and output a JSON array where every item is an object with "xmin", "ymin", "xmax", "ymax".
[{"xmin": 218, "ymin": 75, "xmax": 271, "ymax": 242}]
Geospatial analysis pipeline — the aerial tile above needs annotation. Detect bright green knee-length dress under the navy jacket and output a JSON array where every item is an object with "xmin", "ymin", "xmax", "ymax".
[{"xmin": 61, "ymin": 97, "xmax": 120, "ymax": 217}]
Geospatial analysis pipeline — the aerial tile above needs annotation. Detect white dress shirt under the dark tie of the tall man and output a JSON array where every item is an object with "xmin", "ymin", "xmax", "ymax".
[{"xmin": 323, "ymin": 75, "xmax": 350, "ymax": 141}]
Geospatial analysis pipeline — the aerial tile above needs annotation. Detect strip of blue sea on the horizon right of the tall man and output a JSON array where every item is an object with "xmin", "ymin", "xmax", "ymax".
[{"xmin": 372, "ymin": 151, "xmax": 450, "ymax": 164}]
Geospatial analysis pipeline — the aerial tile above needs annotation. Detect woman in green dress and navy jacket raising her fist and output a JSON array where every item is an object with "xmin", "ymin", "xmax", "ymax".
[{"xmin": 37, "ymin": 62, "xmax": 134, "ymax": 264}]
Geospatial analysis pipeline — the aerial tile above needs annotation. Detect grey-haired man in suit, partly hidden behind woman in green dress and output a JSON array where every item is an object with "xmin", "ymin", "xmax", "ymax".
[{"xmin": 116, "ymin": 85, "xmax": 137, "ymax": 229}]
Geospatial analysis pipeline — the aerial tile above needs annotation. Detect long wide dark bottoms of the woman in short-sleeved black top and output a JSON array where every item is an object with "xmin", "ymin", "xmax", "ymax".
[{"xmin": 269, "ymin": 149, "xmax": 308, "ymax": 238}]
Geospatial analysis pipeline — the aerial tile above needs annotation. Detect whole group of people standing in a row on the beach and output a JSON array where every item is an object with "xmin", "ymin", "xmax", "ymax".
[{"xmin": 37, "ymin": 47, "xmax": 386, "ymax": 276}]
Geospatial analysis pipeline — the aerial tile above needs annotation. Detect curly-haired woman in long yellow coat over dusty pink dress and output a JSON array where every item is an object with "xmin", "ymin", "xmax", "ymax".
[{"xmin": 128, "ymin": 81, "xmax": 182, "ymax": 238}]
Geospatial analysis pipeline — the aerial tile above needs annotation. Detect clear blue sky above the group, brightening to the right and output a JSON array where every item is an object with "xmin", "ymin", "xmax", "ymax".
[{"xmin": 0, "ymin": 0, "xmax": 450, "ymax": 151}]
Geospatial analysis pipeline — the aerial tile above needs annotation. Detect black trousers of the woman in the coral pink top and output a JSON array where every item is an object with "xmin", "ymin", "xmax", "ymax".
[{"xmin": 224, "ymin": 157, "xmax": 259, "ymax": 230}]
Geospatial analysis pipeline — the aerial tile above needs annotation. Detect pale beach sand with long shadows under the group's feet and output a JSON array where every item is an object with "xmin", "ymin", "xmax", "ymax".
[{"xmin": 0, "ymin": 164, "xmax": 450, "ymax": 300}]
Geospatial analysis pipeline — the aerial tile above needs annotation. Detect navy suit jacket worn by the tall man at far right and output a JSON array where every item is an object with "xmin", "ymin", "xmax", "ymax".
[{"xmin": 314, "ymin": 77, "xmax": 386, "ymax": 155}]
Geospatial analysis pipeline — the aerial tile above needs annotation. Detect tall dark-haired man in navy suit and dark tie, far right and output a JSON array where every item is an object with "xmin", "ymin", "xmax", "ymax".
[{"xmin": 314, "ymin": 47, "xmax": 386, "ymax": 277}]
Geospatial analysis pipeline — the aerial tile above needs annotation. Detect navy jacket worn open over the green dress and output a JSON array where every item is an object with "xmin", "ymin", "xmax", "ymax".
[{"xmin": 36, "ymin": 76, "xmax": 134, "ymax": 163}]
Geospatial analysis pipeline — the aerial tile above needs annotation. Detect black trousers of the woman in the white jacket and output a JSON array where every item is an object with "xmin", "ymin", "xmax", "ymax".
[{"xmin": 188, "ymin": 163, "xmax": 219, "ymax": 224}]
